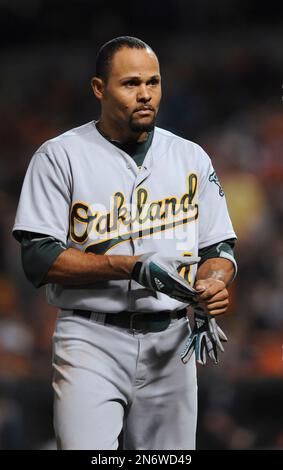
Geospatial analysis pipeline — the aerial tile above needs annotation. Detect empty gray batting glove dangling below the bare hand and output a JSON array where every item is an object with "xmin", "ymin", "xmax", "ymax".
[{"xmin": 181, "ymin": 305, "xmax": 228, "ymax": 365}]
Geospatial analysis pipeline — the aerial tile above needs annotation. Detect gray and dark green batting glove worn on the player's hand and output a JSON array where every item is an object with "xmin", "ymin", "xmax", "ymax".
[{"xmin": 131, "ymin": 253, "xmax": 200, "ymax": 304}]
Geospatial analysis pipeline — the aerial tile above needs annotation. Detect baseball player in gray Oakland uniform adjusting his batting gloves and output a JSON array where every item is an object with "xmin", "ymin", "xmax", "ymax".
[{"xmin": 13, "ymin": 36, "xmax": 236, "ymax": 450}]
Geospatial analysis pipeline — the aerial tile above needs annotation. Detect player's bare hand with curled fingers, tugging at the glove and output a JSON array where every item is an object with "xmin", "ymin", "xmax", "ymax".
[{"xmin": 195, "ymin": 278, "xmax": 229, "ymax": 315}]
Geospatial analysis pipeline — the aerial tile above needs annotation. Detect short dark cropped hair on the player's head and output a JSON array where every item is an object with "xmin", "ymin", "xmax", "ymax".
[{"xmin": 95, "ymin": 36, "xmax": 153, "ymax": 82}]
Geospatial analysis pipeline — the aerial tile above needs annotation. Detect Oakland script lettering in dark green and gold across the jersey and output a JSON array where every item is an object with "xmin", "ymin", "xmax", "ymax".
[{"xmin": 70, "ymin": 173, "xmax": 198, "ymax": 253}]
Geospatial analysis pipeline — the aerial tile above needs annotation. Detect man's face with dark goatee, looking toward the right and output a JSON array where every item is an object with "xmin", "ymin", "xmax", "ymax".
[{"xmin": 97, "ymin": 47, "xmax": 161, "ymax": 133}]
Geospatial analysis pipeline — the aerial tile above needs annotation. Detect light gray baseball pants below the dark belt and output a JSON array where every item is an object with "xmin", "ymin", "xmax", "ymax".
[{"xmin": 53, "ymin": 311, "xmax": 197, "ymax": 450}]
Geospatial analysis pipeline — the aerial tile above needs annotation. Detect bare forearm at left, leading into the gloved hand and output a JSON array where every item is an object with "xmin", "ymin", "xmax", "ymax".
[{"xmin": 45, "ymin": 248, "xmax": 139, "ymax": 286}]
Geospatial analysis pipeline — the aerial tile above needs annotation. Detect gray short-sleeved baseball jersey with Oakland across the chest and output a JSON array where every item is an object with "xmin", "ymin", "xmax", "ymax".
[{"xmin": 13, "ymin": 121, "xmax": 236, "ymax": 312}]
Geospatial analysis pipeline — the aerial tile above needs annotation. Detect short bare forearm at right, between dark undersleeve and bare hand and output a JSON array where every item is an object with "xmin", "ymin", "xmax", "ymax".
[{"xmin": 196, "ymin": 258, "xmax": 235, "ymax": 286}]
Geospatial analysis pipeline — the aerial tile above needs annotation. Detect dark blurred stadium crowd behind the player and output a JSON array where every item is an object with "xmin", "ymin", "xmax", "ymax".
[{"xmin": 0, "ymin": 0, "xmax": 283, "ymax": 449}]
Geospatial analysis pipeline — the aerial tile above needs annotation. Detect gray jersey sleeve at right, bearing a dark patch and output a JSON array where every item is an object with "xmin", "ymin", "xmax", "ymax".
[{"xmin": 199, "ymin": 150, "xmax": 237, "ymax": 249}]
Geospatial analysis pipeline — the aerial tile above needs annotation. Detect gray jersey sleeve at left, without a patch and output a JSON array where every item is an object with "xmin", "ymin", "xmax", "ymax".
[{"xmin": 13, "ymin": 150, "xmax": 71, "ymax": 244}]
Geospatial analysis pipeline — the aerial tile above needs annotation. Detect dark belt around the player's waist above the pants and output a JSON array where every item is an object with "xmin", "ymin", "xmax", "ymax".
[{"xmin": 73, "ymin": 308, "xmax": 187, "ymax": 332}]
